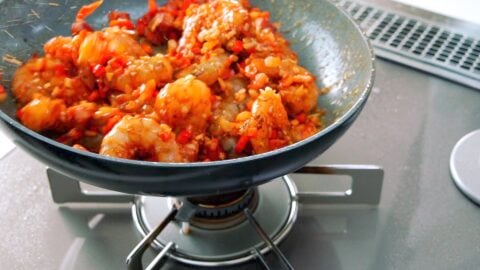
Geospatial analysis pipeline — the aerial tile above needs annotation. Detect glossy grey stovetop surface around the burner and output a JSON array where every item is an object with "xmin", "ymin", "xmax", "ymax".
[{"xmin": 0, "ymin": 1, "xmax": 480, "ymax": 270}]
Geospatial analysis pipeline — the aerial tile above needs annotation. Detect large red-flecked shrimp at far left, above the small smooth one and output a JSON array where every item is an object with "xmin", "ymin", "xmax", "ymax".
[{"xmin": 12, "ymin": 56, "xmax": 89, "ymax": 104}]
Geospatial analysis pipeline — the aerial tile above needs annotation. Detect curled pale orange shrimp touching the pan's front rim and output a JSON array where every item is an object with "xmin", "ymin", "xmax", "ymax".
[{"xmin": 100, "ymin": 116, "xmax": 183, "ymax": 162}]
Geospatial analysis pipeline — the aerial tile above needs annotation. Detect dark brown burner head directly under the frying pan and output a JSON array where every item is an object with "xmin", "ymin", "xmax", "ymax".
[{"xmin": 174, "ymin": 188, "xmax": 258, "ymax": 229}]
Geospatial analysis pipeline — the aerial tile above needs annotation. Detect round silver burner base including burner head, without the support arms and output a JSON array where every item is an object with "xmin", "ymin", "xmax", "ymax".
[{"xmin": 132, "ymin": 176, "xmax": 298, "ymax": 267}]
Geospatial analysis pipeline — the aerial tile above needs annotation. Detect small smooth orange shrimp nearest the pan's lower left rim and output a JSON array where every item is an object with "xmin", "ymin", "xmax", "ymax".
[{"xmin": 17, "ymin": 96, "xmax": 66, "ymax": 131}]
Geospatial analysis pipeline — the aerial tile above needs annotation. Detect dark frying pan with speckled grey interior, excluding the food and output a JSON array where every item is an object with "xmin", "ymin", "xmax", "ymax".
[{"xmin": 0, "ymin": 0, "xmax": 374, "ymax": 196}]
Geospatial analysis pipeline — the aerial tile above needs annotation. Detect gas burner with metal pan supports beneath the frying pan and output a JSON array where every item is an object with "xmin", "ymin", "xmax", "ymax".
[{"xmin": 47, "ymin": 165, "xmax": 383, "ymax": 270}]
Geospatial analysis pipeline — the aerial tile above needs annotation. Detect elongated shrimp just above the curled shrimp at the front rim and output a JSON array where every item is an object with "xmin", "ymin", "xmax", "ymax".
[{"xmin": 106, "ymin": 54, "xmax": 173, "ymax": 93}]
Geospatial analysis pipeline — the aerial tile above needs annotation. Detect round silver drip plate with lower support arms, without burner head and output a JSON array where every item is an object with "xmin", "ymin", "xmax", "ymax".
[{"xmin": 127, "ymin": 176, "xmax": 298, "ymax": 269}]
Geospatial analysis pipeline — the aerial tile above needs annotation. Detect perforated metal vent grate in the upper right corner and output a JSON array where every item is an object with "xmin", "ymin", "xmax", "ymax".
[{"xmin": 337, "ymin": 1, "xmax": 480, "ymax": 90}]
